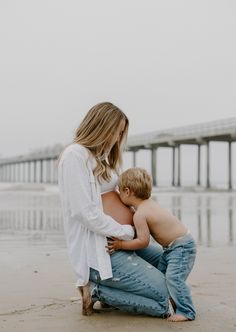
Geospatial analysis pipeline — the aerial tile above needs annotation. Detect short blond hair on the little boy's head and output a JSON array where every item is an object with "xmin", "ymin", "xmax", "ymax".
[{"xmin": 118, "ymin": 167, "xmax": 152, "ymax": 199}]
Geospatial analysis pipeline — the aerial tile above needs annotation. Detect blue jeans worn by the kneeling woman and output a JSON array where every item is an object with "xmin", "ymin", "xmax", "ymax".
[{"xmin": 90, "ymin": 244, "xmax": 169, "ymax": 317}]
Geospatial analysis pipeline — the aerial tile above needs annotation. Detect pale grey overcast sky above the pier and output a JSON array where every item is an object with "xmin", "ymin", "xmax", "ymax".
[{"xmin": 0, "ymin": 0, "xmax": 236, "ymax": 157}]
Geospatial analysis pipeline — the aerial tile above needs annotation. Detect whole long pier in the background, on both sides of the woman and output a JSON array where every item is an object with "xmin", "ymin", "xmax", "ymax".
[{"xmin": 0, "ymin": 117, "xmax": 236, "ymax": 190}]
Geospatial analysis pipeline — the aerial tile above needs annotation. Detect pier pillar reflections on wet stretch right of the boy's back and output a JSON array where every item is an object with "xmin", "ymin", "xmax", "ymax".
[{"xmin": 154, "ymin": 193, "xmax": 236, "ymax": 247}]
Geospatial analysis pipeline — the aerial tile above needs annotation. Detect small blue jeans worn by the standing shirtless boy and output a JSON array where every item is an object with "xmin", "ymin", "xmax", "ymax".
[{"xmin": 158, "ymin": 234, "xmax": 196, "ymax": 320}]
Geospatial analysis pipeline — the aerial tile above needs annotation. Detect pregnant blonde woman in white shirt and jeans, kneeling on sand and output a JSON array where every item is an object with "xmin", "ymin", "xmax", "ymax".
[{"xmin": 58, "ymin": 103, "xmax": 168, "ymax": 317}]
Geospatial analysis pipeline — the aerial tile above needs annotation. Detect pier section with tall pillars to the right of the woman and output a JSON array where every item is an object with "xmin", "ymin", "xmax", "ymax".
[{"xmin": 127, "ymin": 118, "xmax": 236, "ymax": 190}]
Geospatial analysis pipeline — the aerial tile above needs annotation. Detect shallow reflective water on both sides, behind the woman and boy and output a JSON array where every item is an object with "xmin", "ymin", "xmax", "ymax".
[{"xmin": 0, "ymin": 190, "xmax": 236, "ymax": 248}]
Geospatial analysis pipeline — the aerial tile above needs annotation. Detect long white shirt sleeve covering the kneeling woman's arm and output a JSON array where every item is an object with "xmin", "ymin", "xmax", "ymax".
[{"xmin": 59, "ymin": 150, "xmax": 134, "ymax": 240}]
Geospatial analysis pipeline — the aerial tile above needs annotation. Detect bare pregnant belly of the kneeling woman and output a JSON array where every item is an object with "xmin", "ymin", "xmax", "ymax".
[{"xmin": 102, "ymin": 191, "xmax": 133, "ymax": 225}]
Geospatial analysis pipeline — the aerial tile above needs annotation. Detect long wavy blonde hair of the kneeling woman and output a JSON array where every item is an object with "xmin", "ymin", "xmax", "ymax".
[{"xmin": 74, "ymin": 102, "xmax": 129, "ymax": 183}]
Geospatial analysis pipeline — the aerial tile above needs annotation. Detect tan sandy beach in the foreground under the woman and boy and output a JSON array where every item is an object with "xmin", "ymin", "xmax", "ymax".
[{"xmin": 0, "ymin": 183, "xmax": 236, "ymax": 332}]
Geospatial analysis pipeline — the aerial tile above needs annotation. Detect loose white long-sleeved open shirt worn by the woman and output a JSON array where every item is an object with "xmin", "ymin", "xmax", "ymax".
[{"xmin": 58, "ymin": 144, "xmax": 134, "ymax": 286}]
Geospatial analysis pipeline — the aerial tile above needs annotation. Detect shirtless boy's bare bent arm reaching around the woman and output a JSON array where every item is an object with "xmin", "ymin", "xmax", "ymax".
[{"xmin": 106, "ymin": 214, "xmax": 150, "ymax": 254}]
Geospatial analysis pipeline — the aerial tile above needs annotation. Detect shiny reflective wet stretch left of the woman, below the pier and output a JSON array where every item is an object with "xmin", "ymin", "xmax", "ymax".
[{"xmin": 0, "ymin": 191, "xmax": 65, "ymax": 246}]
